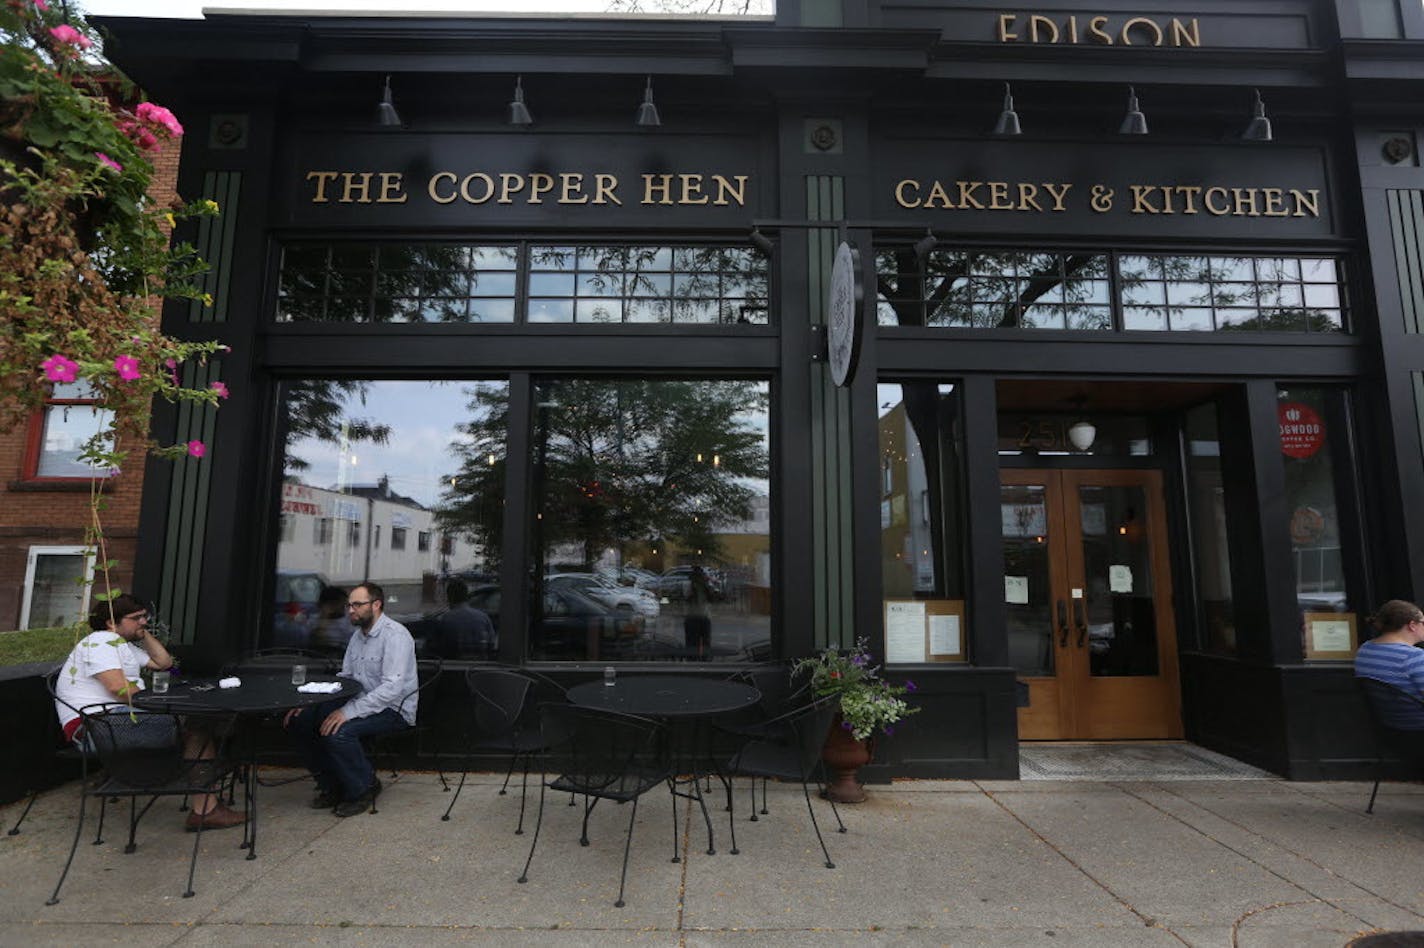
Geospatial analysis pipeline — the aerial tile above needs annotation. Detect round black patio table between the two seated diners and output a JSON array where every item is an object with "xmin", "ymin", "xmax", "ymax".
[{"xmin": 134, "ymin": 668, "xmax": 362, "ymax": 860}]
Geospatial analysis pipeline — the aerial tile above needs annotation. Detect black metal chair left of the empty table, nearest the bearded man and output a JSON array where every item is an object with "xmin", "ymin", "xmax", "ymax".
[{"xmin": 440, "ymin": 668, "xmax": 544, "ymax": 836}]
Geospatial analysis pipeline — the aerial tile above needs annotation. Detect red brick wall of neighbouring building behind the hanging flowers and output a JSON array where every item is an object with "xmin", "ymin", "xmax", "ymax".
[{"xmin": 0, "ymin": 123, "xmax": 179, "ymax": 631}]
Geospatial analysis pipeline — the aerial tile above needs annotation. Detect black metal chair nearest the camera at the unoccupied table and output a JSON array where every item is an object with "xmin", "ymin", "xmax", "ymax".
[{"xmin": 518, "ymin": 705, "xmax": 669, "ymax": 908}]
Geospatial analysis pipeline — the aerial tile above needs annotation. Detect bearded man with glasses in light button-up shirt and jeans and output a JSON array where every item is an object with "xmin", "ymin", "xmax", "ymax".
[{"xmin": 285, "ymin": 582, "xmax": 416, "ymax": 817}]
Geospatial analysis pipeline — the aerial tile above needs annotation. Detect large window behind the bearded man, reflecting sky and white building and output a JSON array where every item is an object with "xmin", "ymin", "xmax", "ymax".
[{"xmin": 263, "ymin": 379, "xmax": 508, "ymax": 659}]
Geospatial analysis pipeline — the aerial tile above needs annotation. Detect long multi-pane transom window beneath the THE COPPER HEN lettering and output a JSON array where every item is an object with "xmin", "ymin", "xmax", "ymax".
[{"xmin": 276, "ymin": 243, "xmax": 768, "ymax": 325}]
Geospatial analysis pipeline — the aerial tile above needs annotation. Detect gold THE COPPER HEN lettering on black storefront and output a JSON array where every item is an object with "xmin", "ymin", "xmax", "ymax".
[{"xmin": 305, "ymin": 171, "xmax": 750, "ymax": 208}]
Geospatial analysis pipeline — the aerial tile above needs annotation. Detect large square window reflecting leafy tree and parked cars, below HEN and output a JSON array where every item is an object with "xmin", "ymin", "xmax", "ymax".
[{"xmin": 529, "ymin": 377, "xmax": 773, "ymax": 662}]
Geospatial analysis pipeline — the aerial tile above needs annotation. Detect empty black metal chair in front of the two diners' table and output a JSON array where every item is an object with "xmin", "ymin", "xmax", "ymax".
[{"xmin": 46, "ymin": 706, "xmax": 242, "ymax": 905}]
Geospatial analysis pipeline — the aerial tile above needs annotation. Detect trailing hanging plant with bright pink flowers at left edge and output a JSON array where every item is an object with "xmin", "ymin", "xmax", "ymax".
[{"xmin": 0, "ymin": 0, "xmax": 228, "ymax": 632}]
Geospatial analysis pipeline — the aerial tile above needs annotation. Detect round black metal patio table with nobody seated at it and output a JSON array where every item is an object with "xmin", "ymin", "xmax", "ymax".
[{"xmin": 568, "ymin": 675, "xmax": 762, "ymax": 863}]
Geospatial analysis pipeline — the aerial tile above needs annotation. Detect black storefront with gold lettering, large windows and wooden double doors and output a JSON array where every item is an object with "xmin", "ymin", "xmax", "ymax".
[{"xmin": 105, "ymin": 0, "xmax": 1424, "ymax": 779}]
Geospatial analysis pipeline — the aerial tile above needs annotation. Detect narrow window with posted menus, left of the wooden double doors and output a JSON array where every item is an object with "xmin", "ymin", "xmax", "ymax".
[{"xmin": 876, "ymin": 380, "xmax": 968, "ymax": 663}]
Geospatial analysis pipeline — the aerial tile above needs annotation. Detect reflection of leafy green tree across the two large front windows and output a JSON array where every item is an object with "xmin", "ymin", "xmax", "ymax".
[{"xmin": 439, "ymin": 379, "xmax": 769, "ymax": 571}]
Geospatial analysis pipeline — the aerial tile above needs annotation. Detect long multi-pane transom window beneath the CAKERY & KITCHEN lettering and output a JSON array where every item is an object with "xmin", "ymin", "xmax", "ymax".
[{"xmin": 876, "ymin": 248, "xmax": 1347, "ymax": 333}]
